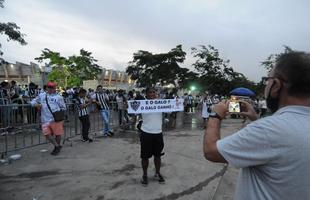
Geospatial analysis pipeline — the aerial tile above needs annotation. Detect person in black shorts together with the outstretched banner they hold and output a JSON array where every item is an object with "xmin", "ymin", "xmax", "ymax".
[{"xmin": 128, "ymin": 87, "xmax": 184, "ymax": 186}]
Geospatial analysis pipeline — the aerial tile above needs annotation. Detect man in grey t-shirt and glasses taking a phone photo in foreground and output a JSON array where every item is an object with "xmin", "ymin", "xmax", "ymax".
[{"xmin": 203, "ymin": 52, "xmax": 310, "ymax": 200}]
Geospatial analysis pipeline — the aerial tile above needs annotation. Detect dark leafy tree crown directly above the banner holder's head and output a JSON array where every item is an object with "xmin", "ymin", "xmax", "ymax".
[{"xmin": 126, "ymin": 45, "xmax": 193, "ymax": 87}]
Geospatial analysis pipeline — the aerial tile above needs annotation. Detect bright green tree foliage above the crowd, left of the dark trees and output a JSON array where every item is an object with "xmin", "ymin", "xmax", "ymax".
[{"xmin": 35, "ymin": 48, "xmax": 102, "ymax": 87}]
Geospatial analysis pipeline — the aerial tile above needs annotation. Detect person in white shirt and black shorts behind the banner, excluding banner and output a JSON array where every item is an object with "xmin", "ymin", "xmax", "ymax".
[{"xmin": 140, "ymin": 87, "xmax": 165, "ymax": 186}]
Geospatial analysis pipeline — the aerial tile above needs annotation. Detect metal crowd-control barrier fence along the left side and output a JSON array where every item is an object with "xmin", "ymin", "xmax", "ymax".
[{"xmin": 0, "ymin": 102, "xmax": 128, "ymax": 158}]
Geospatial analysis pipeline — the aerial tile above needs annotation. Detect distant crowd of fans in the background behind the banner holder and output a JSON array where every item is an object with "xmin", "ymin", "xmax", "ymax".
[{"xmin": 0, "ymin": 80, "xmax": 267, "ymax": 128}]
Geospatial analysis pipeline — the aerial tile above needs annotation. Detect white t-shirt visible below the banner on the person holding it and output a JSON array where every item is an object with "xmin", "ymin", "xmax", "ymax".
[{"xmin": 141, "ymin": 113, "xmax": 163, "ymax": 134}]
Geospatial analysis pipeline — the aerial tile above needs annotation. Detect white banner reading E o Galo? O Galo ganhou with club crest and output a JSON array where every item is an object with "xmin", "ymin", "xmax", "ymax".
[{"xmin": 128, "ymin": 99, "xmax": 184, "ymax": 114}]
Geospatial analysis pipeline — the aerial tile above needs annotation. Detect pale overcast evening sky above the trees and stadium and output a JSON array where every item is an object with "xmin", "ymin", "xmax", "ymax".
[{"xmin": 0, "ymin": 0, "xmax": 310, "ymax": 81}]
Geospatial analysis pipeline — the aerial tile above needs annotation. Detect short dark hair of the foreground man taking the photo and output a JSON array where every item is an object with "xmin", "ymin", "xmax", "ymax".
[{"xmin": 275, "ymin": 51, "xmax": 310, "ymax": 97}]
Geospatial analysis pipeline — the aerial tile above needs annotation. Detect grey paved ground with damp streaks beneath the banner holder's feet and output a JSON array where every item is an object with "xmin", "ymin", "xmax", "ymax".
[{"xmin": 0, "ymin": 114, "xmax": 241, "ymax": 200}]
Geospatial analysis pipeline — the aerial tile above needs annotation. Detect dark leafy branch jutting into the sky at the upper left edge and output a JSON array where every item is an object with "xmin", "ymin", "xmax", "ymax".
[{"xmin": 0, "ymin": 0, "xmax": 27, "ymax": 56}]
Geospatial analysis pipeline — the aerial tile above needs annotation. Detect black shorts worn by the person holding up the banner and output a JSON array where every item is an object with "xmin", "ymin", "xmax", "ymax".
[{"xmin": 140, "ymin": 131, "xmax": 164, "ymax": 158}]
